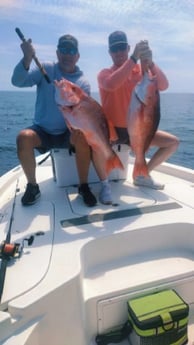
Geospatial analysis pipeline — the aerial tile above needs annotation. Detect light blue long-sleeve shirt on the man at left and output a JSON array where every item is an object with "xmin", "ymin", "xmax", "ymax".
[{"xmin": 11, "ymin": 60, "xmax": 90, "ymax": 135}]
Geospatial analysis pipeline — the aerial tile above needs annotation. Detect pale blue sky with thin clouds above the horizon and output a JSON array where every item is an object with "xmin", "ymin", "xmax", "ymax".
[{"xmin": 0, "ymin": 0, "xmax": 194, "ymax": 93}]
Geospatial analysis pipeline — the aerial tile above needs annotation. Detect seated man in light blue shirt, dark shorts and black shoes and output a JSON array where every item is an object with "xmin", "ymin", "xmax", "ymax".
[{"xmin": 12, "ymin": 35, "xmax": 110, "ymax": 206}]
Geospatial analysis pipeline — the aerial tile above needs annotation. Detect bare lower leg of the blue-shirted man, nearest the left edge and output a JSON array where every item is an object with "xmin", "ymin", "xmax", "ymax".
[{"xmin": 17, "ymin": 129, "xmax": 41, "ymax": 184}]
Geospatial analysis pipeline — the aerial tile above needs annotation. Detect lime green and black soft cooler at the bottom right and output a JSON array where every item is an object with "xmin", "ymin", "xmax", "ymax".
[{"xmin": 127, "ymin": 290, "xmax": 189, "ymax": 345}]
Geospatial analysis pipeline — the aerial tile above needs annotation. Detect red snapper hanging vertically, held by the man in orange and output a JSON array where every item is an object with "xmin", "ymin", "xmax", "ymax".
[{"xmin": 127, "ymin": 72, "xmax": 160, "ymax": 179}]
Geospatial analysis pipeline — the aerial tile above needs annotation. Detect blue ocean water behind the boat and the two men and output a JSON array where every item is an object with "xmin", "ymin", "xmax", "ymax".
[{"xmin": 0, "ymin": 91, "xmax": 194, "ymax": 175}]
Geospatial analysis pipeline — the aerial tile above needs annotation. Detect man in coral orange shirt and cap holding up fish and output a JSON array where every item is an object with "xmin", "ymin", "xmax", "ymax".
[{"xmin": 98, "ymin": 31, "xmax": 179, "ymax": 189}]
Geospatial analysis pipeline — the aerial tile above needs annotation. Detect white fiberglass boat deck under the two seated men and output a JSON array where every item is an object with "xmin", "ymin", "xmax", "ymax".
[{"xmin": 0, "ymin": 146, "xmax": 194, "ymax": 345}]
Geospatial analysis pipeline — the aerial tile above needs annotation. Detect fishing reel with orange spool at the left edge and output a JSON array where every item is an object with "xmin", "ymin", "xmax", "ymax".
[{"xmin": 0, "ymin": 235, "xmax": 34, "ymax": 260}]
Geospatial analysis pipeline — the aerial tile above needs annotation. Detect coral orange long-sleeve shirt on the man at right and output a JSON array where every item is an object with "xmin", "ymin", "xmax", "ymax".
[{"xmin": 98, "ymin": 59, "xmax": 168, "ymax": 128}]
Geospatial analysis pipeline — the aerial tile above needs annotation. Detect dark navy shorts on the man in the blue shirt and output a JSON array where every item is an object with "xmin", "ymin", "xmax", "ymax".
[{"xmin": 28, "ymin": 125, "xmax": 71, "ymax": 153}]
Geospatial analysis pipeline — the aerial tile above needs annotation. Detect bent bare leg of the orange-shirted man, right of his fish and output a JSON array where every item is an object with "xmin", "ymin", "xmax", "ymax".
[{"xmin": 148, "ymin": 131, "xmax": 179, "ymax": 172}]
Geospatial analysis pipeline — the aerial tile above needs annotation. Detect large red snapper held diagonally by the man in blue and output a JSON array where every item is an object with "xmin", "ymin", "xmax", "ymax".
[{"xmin": 55, "ymin": 79, "xmax": 123, "ymax": 174}]
